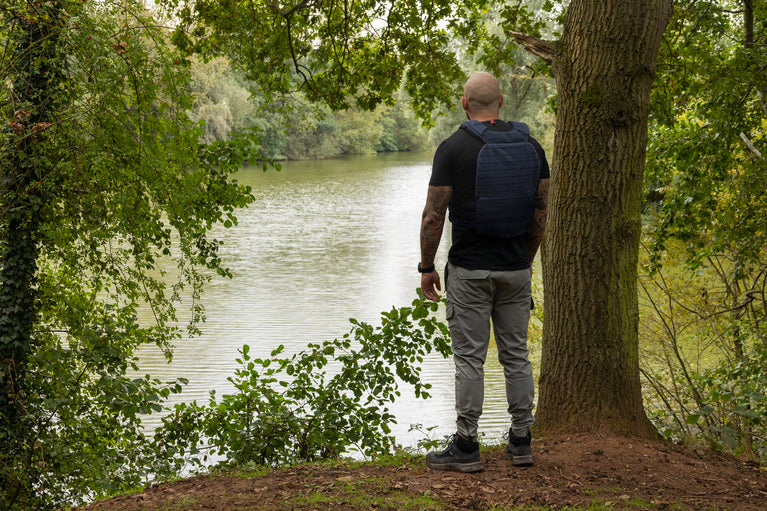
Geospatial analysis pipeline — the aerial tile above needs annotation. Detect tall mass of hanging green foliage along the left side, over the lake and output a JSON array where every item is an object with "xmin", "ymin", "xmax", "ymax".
[{"xmin": 0, "ymin": 0, "xmax": 254, "ymax": 509}]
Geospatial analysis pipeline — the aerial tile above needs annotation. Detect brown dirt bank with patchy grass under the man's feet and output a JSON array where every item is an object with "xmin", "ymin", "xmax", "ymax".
[{"xmin": 86, "ymin": 436, "xmax": 767, "ymax": 511}]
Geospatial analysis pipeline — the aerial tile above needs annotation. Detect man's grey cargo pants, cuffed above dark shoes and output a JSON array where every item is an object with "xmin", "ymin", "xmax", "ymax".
[{"xmin": 446, "ymin": 263, "xmax": 535, "ymax": 441}]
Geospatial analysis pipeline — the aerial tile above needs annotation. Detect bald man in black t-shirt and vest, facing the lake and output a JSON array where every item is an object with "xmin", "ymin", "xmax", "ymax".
[{"xmin": 418, "ymin": 73, "xmax": 549, "ymax": 472}]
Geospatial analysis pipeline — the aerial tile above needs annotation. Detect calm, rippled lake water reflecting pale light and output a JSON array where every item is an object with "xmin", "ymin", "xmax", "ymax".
[{"xmin": 141, "ymin": 153, "xmax": 536, "ymax": 445}]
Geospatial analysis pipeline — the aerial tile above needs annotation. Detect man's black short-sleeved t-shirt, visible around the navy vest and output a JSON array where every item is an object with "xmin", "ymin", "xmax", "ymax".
[{"xmin": 429, "ymin": 121, "xmax": 549, "ymax": 271}]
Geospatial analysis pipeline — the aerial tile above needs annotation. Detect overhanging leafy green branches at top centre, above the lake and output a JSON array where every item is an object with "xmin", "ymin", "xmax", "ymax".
[{"xmin": 162, "ymin": 0, "xmax": 498, "ymax": 119}]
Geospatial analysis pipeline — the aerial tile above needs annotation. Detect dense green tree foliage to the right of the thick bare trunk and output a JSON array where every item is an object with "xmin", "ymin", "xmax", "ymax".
[{"xmin": 646, "ymin": 1, "xmax": 767, "ymax": 269}]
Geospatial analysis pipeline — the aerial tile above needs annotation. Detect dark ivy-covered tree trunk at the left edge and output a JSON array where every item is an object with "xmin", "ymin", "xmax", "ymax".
[{"xmin": 0, "ymin": 0, "xmax": 64, "ymax": 450}]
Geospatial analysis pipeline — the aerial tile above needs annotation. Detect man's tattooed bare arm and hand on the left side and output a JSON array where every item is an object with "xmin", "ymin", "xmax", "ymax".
[{"xmin": 421, "ymin": 186, "xmax": 453, "ymax": 301}]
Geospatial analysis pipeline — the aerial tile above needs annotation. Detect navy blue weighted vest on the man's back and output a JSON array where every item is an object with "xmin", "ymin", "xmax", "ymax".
[{"xmin": 450, "ymin": 121, "xmax": 540, "ymax": 238}]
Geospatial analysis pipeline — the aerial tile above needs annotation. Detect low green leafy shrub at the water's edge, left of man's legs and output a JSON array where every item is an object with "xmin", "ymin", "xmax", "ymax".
[{"xmin": 155, "ymin": 296, "xmax": 450, "ymax": 465}]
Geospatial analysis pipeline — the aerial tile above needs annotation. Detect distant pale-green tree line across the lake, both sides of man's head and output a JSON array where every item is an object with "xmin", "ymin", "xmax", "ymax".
[{"xmin": 190, "ymin": 57, "xmax": 554, "ymax": 160}]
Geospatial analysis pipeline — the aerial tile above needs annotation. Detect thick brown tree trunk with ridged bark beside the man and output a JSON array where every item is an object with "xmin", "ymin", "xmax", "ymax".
[{"xmin": 536, "ymin": 0, "xmax": 673, "ymax": 437}]
